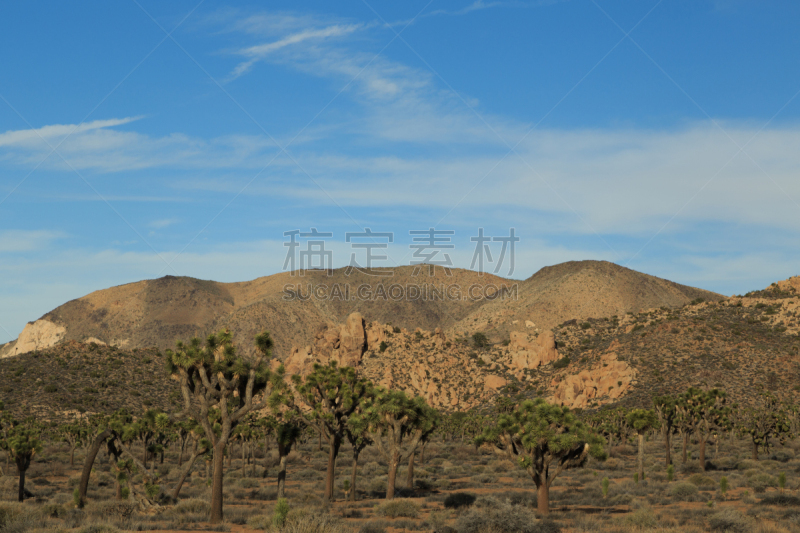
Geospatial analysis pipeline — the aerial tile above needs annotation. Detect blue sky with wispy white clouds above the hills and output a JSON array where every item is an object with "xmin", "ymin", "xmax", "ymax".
[{"xmin": 0, "ymin": 0, "xmax": 800, "ymax": 342}]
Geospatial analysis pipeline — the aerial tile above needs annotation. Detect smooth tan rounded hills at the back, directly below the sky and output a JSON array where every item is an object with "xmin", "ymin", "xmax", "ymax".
[{"xmin": 0, "ymin": 261, "xmax": 722, "ymax": 358}]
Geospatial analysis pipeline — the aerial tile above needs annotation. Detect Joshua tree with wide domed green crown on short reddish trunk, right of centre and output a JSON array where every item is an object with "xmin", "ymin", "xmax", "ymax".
[{"xmin": 476, "ymin": 398, "xmax": 606, "ymax": 515}]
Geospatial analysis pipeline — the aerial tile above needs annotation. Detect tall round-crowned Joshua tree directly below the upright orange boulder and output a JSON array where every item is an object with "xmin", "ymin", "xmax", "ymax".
[{"xmin": 292, "ymin": 361, "xmax": 372, "ymax": 501}]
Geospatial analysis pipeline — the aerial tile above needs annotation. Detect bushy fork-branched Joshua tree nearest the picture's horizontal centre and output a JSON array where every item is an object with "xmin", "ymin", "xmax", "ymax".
[{"xmin": 364, "ymin": 389, "xmax": 439, "ymax": 500}]
